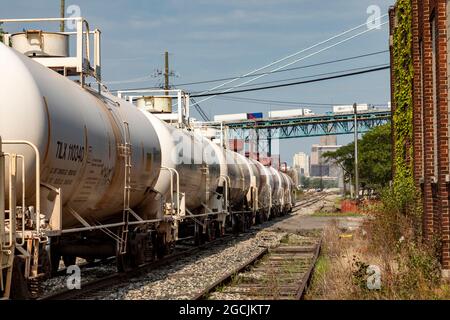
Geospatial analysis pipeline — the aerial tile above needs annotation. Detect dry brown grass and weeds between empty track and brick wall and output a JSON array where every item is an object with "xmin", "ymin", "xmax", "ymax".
[{"xmin": 306, "ymin": 200, "xmax": 450, "ymax": 300}]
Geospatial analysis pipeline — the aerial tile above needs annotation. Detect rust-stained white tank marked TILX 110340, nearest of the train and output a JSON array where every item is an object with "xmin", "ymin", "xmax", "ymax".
[{"xmin": 0, "ymin": 43, "xmax": 161, "ymax": 227}]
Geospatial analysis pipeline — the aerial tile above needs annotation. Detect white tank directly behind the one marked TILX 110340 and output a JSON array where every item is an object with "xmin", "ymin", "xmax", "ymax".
[{"xmin": 142, "ymin": 111, "xmax": 221, "ymax": 215}]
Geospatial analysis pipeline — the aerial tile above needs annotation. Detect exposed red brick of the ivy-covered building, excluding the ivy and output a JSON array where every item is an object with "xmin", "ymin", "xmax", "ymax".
[{"xmin": 389, "ymin": 0, "xmax": 450, "ymax": 277}]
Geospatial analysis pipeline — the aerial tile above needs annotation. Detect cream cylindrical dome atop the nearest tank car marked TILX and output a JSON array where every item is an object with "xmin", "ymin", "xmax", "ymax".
[{"xmin": 11, "ymin": 30, "xmax": 69, "ymax": 58}]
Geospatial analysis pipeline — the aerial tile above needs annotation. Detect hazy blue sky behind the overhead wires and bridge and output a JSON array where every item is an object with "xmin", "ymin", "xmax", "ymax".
[{"xmin": 0, "ymin": 0, "xmax": 394, "ymax": 163}]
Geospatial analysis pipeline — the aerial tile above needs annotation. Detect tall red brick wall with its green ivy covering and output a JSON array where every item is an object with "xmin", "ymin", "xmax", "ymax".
[{"xmin": 389, "ymin": 0, "xmax": 450, "ymax": 277}]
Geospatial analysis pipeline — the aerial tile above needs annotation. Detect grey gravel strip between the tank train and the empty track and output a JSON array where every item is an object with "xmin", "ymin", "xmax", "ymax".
[{"xmin": 103, "ymin": 230, "xmax": 286, "ymax": 300}]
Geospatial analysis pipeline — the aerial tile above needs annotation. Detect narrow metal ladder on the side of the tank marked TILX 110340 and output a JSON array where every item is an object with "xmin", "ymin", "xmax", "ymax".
[{"xmin": 118, "ymin": 122, "xmax": 132, "ymax": 254}]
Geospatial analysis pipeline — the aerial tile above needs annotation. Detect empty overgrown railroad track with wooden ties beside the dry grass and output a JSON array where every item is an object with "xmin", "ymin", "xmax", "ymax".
[{"xmin": 193, "ymin": 235, "xmax": 322, "ymax": 300}]
